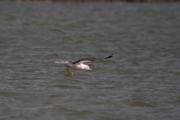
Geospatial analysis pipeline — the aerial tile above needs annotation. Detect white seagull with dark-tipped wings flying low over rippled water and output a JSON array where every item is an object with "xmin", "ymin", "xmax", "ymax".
[{"xmin": 55, "ymin": 54, "xmax": 113, "ymax": 75}]
